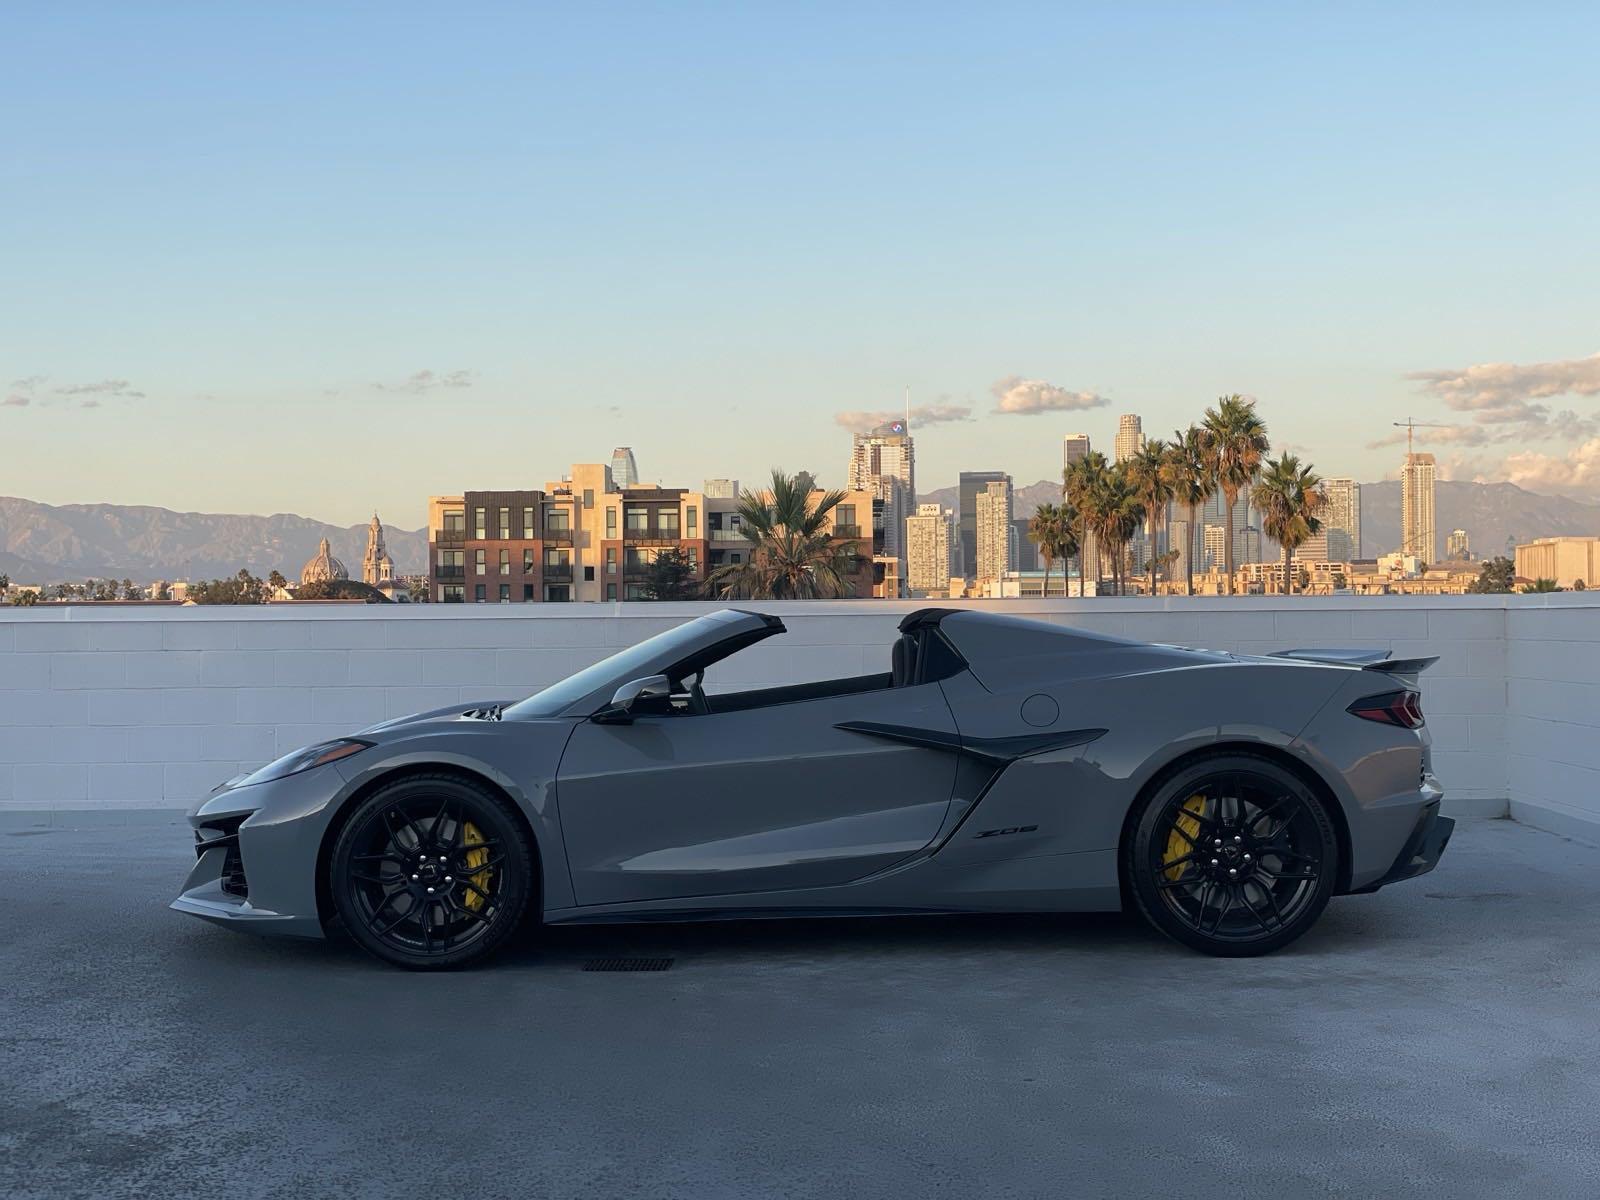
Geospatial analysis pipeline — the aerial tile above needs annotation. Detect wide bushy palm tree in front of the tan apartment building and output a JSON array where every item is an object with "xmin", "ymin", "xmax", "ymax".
[{"xmin": 706, "ymin": 469, "xmax": 861, "ymax": 600}]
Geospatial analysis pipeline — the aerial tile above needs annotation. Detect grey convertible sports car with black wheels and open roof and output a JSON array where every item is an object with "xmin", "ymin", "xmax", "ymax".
[{"xmin": 173, "ymin": 608, "xmax": 1454, "ymax": 968}]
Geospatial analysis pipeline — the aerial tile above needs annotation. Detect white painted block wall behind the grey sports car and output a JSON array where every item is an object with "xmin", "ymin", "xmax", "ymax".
[{"xmin": 0, "ymin": 594, "xmax": 1600, "ymax": 829}]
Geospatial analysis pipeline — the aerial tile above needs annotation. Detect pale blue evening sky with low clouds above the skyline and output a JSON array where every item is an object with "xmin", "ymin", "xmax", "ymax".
[{"xmin": 0, "ymin": 0, "xmax": 1600, "ymax": 528}]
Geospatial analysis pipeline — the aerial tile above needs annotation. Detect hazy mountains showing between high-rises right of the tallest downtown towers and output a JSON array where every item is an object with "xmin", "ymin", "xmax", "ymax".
[{"xmin": 920, "ymin": 480, "xmax": 1600, "ymax": 558}]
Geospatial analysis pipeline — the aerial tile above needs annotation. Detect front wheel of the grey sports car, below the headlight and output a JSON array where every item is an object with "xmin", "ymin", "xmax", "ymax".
[{"xmin": 330, "ymin": 774, "xmax": 536, "ymax": 971}]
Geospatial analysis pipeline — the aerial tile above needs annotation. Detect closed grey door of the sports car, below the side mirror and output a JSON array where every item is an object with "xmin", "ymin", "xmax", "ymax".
[{"xmin": 557, "ymin": 683, "xmax": 955, "ymax": 904}]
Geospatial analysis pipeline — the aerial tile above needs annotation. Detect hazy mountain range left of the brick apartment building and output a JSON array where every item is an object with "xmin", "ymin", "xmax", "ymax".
[{"xmin": 0, "ymin": 496, "xmax": 427, "ymax": 584}]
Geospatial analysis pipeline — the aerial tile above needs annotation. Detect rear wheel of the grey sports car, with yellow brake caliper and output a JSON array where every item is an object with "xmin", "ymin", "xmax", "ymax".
[{"xmin": 1122, "ymin": 754, "xmax": 1339, "ymax": 958}]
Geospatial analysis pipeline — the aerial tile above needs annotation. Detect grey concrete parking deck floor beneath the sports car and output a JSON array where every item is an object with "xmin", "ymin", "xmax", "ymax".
[{"xmin": 0, "ymin": 816, "xmax": 1600, "ymax": 1200}]
